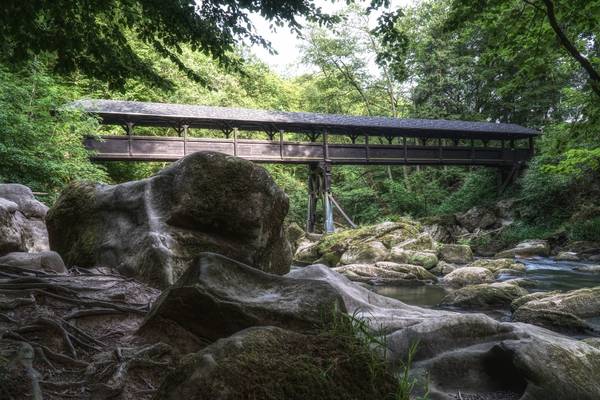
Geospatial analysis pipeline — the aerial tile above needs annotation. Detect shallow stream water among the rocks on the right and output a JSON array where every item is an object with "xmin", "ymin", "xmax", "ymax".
[{"xmin": 370, "ymin": 258, "xmax": 600, "ymax": 307}]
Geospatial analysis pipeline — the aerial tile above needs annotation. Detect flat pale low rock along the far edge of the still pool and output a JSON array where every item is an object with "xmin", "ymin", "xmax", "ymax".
[{"xmin": 333, "ymin": 261, "xmax": 437, "ymax": 285}]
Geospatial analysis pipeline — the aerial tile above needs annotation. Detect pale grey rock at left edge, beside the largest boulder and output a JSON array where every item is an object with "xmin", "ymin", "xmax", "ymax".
[{"xmin": 0, "ymin": 184, "xmax": 49, "ymax": 255}]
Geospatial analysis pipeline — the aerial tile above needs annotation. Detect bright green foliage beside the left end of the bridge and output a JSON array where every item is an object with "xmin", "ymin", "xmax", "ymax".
[{"xmin": 0, "ymin": 61, "xmax": 107, "ymax": 200}]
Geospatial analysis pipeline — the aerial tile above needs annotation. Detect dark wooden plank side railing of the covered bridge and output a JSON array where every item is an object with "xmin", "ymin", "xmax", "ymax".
[{"xmin": 85, "ymin": 135, "xmax": 530, "ymax": 167}]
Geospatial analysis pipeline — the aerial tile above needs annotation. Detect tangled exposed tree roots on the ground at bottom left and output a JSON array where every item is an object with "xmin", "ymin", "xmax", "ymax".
[{"xmin": 0, "ymin": 266, "xmax": 170, "ymax": 400}]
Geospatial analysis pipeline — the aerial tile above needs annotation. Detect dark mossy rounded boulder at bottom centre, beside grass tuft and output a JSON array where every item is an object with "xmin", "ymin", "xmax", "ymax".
[{"xmin": 155, "ymin": 327, "xmax": 397, "ymax": 400}]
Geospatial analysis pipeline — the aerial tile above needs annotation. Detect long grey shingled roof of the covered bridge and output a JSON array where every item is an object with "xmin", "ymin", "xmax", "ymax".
[{"xmin": 72, "ymin": 100, "xmax": 539, "ymax": 139}]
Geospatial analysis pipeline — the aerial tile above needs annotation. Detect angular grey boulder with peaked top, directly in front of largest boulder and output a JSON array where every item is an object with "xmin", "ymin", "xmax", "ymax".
[{"xmin": 145, "ymin": 253, "xmax": 344, "ymax": 341}]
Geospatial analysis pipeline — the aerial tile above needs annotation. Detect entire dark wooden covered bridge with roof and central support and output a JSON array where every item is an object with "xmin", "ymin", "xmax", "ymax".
[{"xmin": 73, "ymin": 100, "xmax": 539, "ymax": 232}]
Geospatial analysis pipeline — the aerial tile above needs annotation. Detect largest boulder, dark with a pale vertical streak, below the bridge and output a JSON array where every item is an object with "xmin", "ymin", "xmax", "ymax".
[{"xmin": 47, "ymin": 152, "xmax": 291, "ymax": 287}]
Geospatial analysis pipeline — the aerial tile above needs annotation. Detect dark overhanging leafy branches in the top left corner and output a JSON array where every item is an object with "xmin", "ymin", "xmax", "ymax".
[{"xmin": 0, "ymin": 0, "xmax": 330, "ymax": 88}]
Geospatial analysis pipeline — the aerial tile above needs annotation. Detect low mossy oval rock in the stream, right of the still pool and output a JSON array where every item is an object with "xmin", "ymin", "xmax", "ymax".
[{"xmin": 440, "ymin": 281, "xmax": 528, "ymax": 309}]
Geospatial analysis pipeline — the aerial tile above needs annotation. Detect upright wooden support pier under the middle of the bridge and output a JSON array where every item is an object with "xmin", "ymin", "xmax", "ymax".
[{"xmin": 306, "ymin": 162, "xmax": 335, "ymax": 233}]
